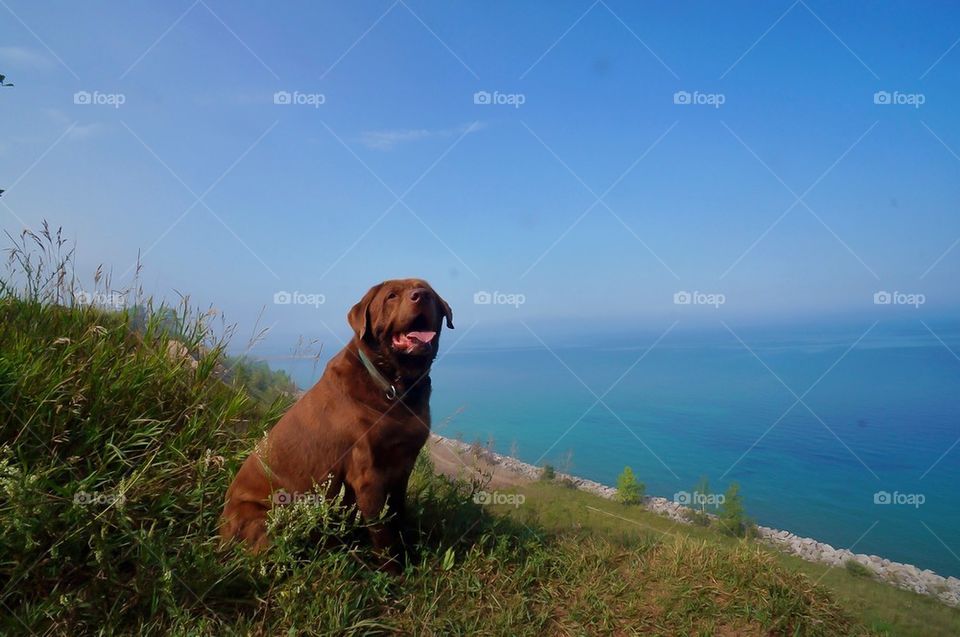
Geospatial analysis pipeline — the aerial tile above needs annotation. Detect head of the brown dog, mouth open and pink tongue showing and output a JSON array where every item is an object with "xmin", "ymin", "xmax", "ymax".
[{"xmin": 347, "ymin": 279, "xmax": 453, "ymax": 373}]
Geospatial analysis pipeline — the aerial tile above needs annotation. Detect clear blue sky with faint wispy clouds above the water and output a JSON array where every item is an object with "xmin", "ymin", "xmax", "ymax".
[{"xmin": 0, "ymin": 0, "xmax": 960, "ymax": 350}]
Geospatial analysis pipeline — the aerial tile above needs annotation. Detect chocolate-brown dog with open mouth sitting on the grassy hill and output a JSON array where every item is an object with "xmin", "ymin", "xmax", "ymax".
[{"xmin": 220, "ymin": 279, "xmax": 453, "ymax": 572}]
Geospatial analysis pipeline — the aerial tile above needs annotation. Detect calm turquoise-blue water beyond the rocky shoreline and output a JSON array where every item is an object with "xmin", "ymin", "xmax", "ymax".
[{"xmin": 278, "ymin": 323, "xmax": 960, "ymax": 576}]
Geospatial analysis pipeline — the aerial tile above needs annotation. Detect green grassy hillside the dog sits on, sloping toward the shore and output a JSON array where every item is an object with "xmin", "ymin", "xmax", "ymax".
[{"xmin": 0, "ymin": 231, "xmax": 958, "ymax": 635}]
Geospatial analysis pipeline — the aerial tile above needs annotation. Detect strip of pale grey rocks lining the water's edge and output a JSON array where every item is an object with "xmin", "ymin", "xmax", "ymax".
[{"xmin": 430, "ymin": 433, "xmax": 960, "ymax": 607}]
